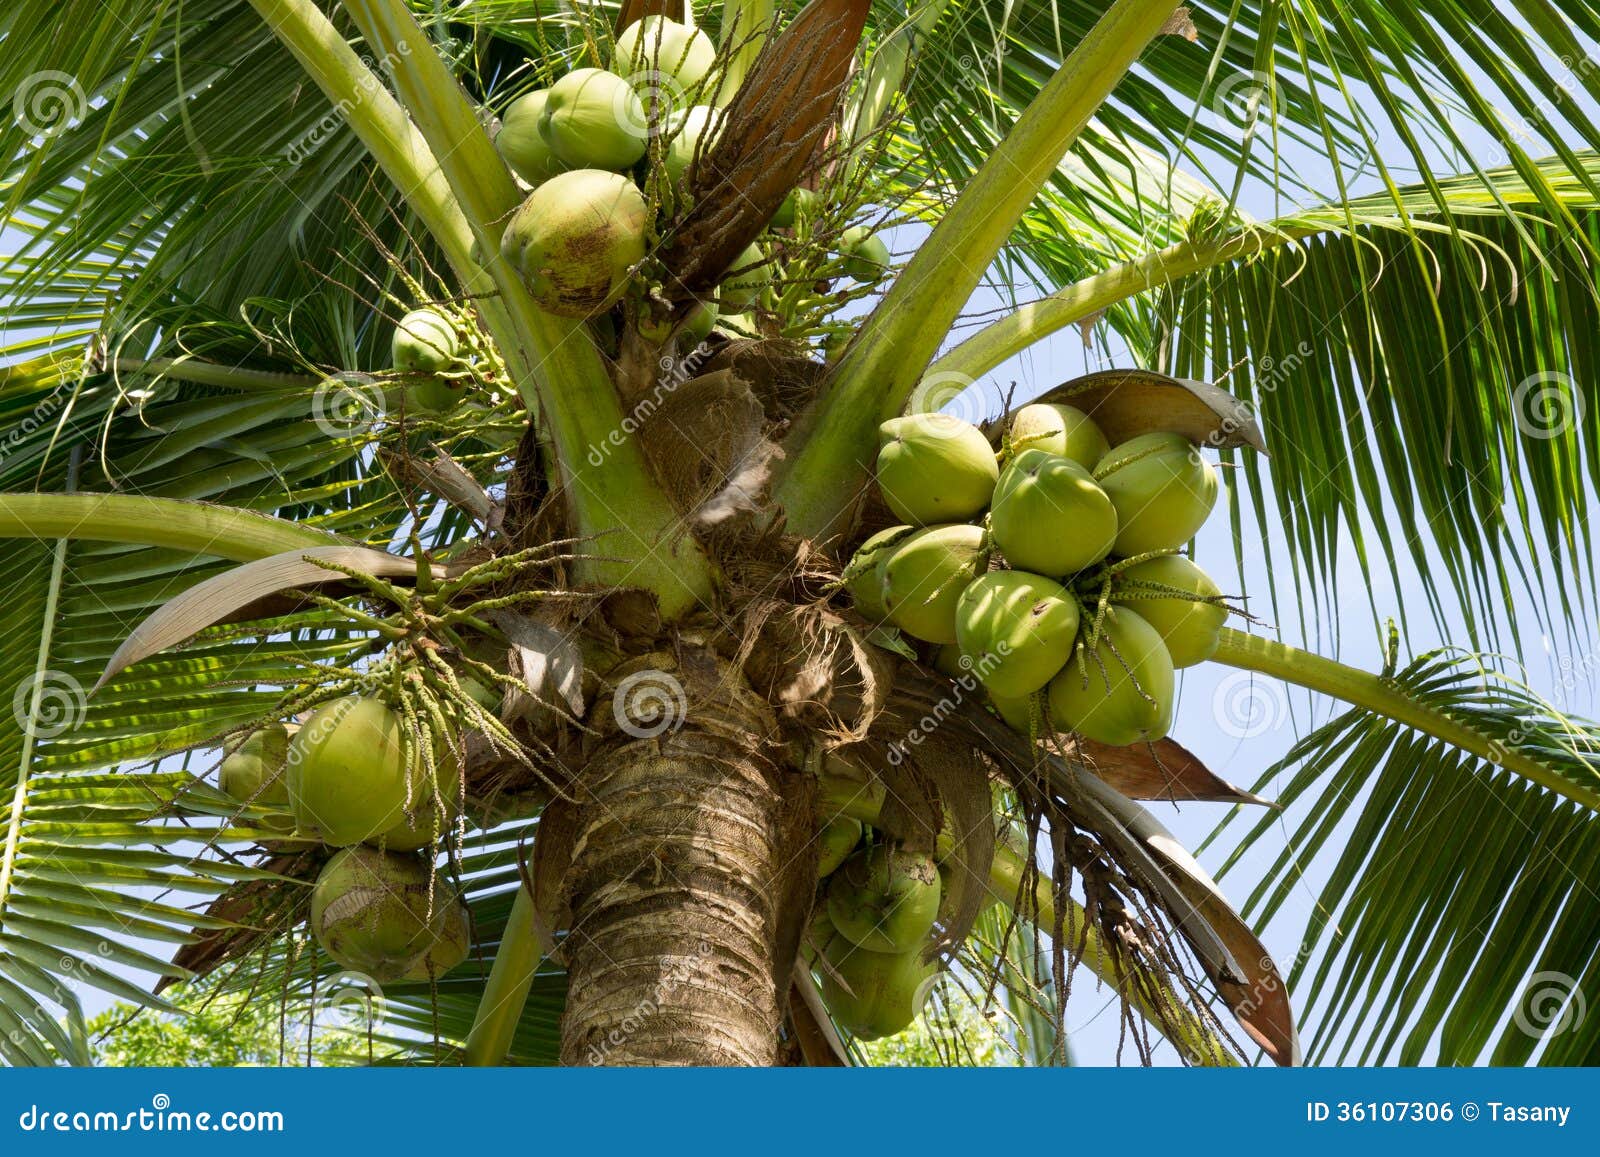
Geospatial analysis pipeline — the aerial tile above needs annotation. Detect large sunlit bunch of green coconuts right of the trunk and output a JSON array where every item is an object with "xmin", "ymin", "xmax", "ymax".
[{"xmin": 843, "ymin": 403, "xmax": 1229, "ymax": 746}]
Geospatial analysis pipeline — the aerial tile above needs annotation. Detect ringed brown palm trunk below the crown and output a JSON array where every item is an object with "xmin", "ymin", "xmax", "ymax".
[{"xmin": 562, "ymin": 651, "xmax": 805, "ymax": 1066}]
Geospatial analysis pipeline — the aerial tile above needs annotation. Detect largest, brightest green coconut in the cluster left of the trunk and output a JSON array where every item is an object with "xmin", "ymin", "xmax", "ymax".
[{"xmin": 285, "ymin": 696, "xmax": 406, "ymax": 848}]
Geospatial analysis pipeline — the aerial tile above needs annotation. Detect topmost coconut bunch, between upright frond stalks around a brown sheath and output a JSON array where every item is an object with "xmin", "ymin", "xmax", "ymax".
[{"xmin": 473, "ymin": 14, "xmax": 890, "ymax": 344}]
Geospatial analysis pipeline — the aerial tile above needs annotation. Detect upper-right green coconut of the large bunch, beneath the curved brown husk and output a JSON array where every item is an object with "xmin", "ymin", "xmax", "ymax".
[{"xmin": 1094, "ymin": 434, "xmax": 1216, "ymax": 558}]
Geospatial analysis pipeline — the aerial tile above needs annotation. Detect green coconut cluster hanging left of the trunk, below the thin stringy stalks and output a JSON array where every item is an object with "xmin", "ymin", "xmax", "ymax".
[{"xmin": 219, "ymin": 696, "xmax": 469, "ymax": 983}]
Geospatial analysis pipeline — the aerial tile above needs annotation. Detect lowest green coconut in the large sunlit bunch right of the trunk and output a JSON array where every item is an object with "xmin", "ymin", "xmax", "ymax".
[{"xmin": 1050, "ymin": 607, "xmax": 1174, "ymax": 747}]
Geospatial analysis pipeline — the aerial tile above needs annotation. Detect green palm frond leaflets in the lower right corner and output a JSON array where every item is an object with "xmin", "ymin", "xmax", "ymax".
[{"xmin": 1213, "ymin": 651, "xmax": 1600, "ymax": 1064}]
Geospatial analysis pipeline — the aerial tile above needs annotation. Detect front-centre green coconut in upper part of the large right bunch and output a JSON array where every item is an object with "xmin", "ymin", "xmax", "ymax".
[{"xmin": 989, "ymin": 450, "xmax": 1117, "ymax": 578}]
